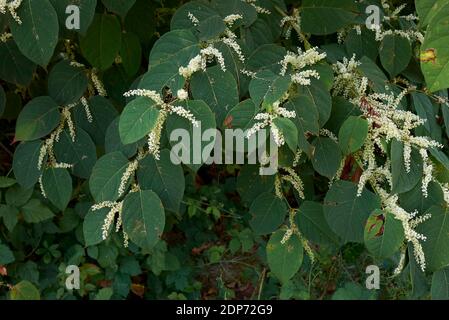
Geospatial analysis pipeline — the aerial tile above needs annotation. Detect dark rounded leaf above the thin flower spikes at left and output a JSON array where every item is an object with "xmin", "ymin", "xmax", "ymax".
[{"xmin": 48, "ymin": 60, "xmax": 87, "ymax": 105}]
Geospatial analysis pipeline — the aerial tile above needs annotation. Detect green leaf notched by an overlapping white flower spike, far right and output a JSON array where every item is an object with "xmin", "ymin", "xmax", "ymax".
[{"xmin": 391, "ymin": 139, "xmax": 423, "ymax": 193}]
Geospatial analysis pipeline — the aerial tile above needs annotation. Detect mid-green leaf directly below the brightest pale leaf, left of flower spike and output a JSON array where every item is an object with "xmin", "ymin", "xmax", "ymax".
[{"xmin": 89, "ymin": 152, "xmax": 129, "ymax": 203}]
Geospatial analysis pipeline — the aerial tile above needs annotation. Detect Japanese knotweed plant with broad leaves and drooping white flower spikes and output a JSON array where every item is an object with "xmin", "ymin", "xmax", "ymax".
[{"xmin": 0, "ymin": 0, "xmax": 449, "ymax": 298}]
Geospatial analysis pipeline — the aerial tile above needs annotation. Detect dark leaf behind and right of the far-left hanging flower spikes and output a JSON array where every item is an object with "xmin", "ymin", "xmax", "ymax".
[{"xmin": 55, "ymin": 128, "xmax": 97, "ymax": 179}]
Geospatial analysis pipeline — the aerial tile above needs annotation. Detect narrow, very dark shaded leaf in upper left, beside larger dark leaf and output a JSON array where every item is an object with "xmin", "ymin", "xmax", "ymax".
[{"xmin": 120, "ymin": 32, "xmax": 142, "ymax": 77}]
